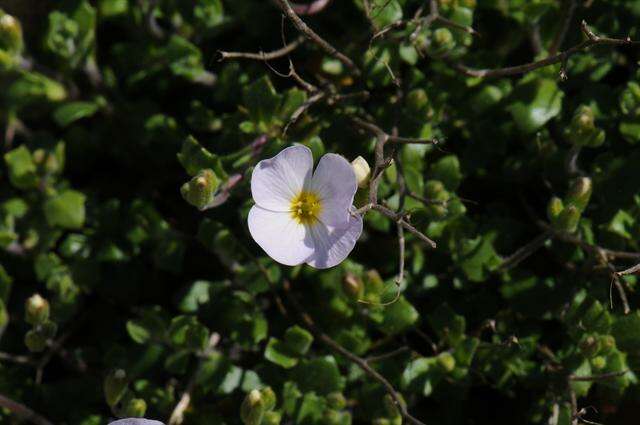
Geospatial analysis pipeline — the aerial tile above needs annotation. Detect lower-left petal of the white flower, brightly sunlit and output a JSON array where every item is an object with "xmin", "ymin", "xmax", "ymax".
[{"xmin": 248, "ymin": 205, "xmax": 315, "ymax": 266}]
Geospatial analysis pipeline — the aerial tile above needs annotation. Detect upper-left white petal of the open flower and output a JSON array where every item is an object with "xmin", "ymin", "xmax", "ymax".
[{"xmin": 251, "ymin": 145, "xmax": 313, "ymax": 211}]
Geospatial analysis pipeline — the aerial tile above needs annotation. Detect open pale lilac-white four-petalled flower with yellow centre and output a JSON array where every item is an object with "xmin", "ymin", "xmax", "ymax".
[{"xmin": 249, "ymin": 146, "xmax": 362, "ymax": 269}]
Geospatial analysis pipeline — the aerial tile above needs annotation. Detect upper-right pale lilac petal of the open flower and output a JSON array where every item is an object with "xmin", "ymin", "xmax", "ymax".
[{"xmin": 309, "ymin": 153, "xmax": 358, "ymax": 227}]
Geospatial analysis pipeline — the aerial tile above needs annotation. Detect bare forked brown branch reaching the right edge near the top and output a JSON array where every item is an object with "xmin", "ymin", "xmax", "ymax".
[{"xmin": 441, "ymin": 21, "xmax": 639, "ymax": 78}]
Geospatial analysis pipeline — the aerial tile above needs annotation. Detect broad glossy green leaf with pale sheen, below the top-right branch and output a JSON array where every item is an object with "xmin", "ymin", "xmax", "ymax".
[{"xmin": 508, "ymin": 79, "xmax": 564, "ymax": 134}]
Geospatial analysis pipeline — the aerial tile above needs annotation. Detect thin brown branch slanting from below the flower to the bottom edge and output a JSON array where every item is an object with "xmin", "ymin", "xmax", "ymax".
[{"xmin": 283, "ymin": 280, "xmax": 425, "ymax": 425}]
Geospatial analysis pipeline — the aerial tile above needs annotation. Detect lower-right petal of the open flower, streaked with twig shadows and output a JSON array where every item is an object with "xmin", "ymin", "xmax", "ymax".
[{"xmin": 307, "ymin": 215, "xmax": 362, "ymax": 269}]
